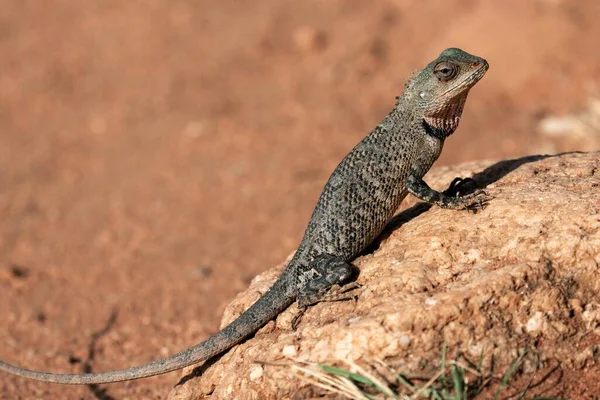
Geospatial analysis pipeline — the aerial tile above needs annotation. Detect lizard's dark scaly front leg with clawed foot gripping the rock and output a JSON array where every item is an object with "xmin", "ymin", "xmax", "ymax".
[{"xmin": 406, "ymin": 174, "xmax": 491, "ymax": 210}]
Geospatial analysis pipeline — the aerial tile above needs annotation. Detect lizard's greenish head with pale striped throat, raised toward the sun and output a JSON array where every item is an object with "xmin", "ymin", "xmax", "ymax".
[{"xmin": 404, "ymin": 49, "xmax": 489, "ymax": 136}]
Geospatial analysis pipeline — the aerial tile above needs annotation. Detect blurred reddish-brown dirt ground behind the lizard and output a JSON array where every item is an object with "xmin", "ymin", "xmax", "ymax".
[{"xmin": 0, "ymin": 0, "xmax": 600, "ymax": 399}]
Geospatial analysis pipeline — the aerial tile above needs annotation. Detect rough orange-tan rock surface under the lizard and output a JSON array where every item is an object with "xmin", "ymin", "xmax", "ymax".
[{"xmin": 170, "ymin": 152, "xmax": 600, "ymax": 399}]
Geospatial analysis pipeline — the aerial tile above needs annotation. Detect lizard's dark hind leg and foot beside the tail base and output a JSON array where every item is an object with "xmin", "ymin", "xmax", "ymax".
[{"xmin": 292, "ymin": 254, "xmax": 360, "ymax": 329}]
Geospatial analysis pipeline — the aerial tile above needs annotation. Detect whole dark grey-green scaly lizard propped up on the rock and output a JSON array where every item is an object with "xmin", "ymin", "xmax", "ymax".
[{"xmin": 0, "ymin": 48, "xmax": 490, "ymax": 385}]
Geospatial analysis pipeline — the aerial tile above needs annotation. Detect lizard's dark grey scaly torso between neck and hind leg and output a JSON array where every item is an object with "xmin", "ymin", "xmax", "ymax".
[{"xmin": 299, "ymin": 108, "xmax": 422, "ymax": 261}]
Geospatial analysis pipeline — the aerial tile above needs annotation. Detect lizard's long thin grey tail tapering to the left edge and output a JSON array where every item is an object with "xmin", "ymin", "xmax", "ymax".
[{"xmin": 0, "ymin": 277, "xmax": 294, "ymax": 385}]
